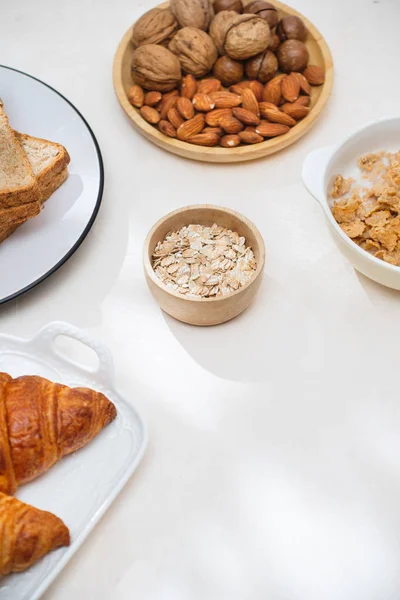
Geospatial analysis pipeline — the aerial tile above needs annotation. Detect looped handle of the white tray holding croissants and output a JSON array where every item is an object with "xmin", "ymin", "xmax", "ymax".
[{"xmin": 33, "ymin": 321, "xmax": 114, "ymax": 384}]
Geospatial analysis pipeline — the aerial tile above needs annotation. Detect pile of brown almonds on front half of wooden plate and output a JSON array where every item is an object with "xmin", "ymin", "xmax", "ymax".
[{"xmin": 128, "ymin": 65, "xmax": 324, "ymax": 148}]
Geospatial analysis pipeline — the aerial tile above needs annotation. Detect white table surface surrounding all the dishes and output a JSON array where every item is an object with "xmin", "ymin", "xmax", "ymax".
[{"xmin": 0, "ymin": 0, "xmax": 400, "ymax": 600}]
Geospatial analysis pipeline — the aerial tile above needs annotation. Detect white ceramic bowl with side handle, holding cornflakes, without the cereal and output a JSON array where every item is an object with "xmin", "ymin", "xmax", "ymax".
[{"xmin": 302, "ymin": 117, "xmax": 400, "ymax": 290}]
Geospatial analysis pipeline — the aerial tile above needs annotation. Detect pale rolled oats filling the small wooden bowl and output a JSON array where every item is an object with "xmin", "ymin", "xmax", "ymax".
[{"xmin": 152, "ymin": 223, "xmax": 257, "ymax": 298}]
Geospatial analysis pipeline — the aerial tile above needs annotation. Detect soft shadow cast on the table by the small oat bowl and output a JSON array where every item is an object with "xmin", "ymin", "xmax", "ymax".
[{"xmin": 163, "ymin": 276, "xmax": 310, "ymax": 382}]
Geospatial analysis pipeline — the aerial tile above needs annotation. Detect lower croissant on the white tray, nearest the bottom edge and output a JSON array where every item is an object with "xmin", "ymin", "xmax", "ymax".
[{"xmin": 0, "ymin": 493, "xmax": 70, "ymax": 576}]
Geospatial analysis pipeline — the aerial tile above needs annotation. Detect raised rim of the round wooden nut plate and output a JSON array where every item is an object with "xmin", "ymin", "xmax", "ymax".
[{"xmin": 113, "ymin": 0, "xmax": 333, "ymax": 164}]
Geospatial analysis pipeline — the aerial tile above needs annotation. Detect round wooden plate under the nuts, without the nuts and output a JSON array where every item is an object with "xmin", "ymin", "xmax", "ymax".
[{"xmin": 113, "ymin": 0, "xmax": 333, "ymax": 163}]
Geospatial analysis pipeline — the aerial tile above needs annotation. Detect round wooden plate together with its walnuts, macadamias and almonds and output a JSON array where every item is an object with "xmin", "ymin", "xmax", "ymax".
[{"xmin": 113, "ymin": 0, "xmax": 333, "ymax": 163}]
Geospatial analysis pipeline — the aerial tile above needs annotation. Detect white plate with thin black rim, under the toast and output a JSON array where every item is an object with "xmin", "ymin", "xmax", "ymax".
[{"xmin": 0, "ymin": 65, "xmax": 104, "ymax": 304}]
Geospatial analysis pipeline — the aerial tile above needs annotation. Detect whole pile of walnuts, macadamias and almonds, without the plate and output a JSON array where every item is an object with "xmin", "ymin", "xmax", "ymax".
[{"xmin": 128, "ymin": 0, "xmax": 325, "ymax": 148}]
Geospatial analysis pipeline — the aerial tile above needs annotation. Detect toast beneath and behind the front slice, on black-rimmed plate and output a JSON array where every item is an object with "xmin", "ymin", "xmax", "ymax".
[{"xmin": 0, "ymin": 132, "xmax": 70, "ymax": 243}]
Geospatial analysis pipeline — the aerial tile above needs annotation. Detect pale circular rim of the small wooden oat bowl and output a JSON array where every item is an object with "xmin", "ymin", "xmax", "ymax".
[{"xmin": 143, "ymin": 204, "xmax": 265, "ymax": 304}]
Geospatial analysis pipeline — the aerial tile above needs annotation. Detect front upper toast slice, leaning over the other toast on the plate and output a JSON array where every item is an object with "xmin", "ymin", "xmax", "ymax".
[{"xmin": 0, "ymin": 105, "xmax": 40, "ymax": 210}]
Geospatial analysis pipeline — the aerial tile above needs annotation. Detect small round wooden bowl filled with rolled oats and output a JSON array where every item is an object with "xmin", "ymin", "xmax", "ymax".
[{"xmin": 143, "ymin": 204, "xmax": 265, "ymax": 326}]
